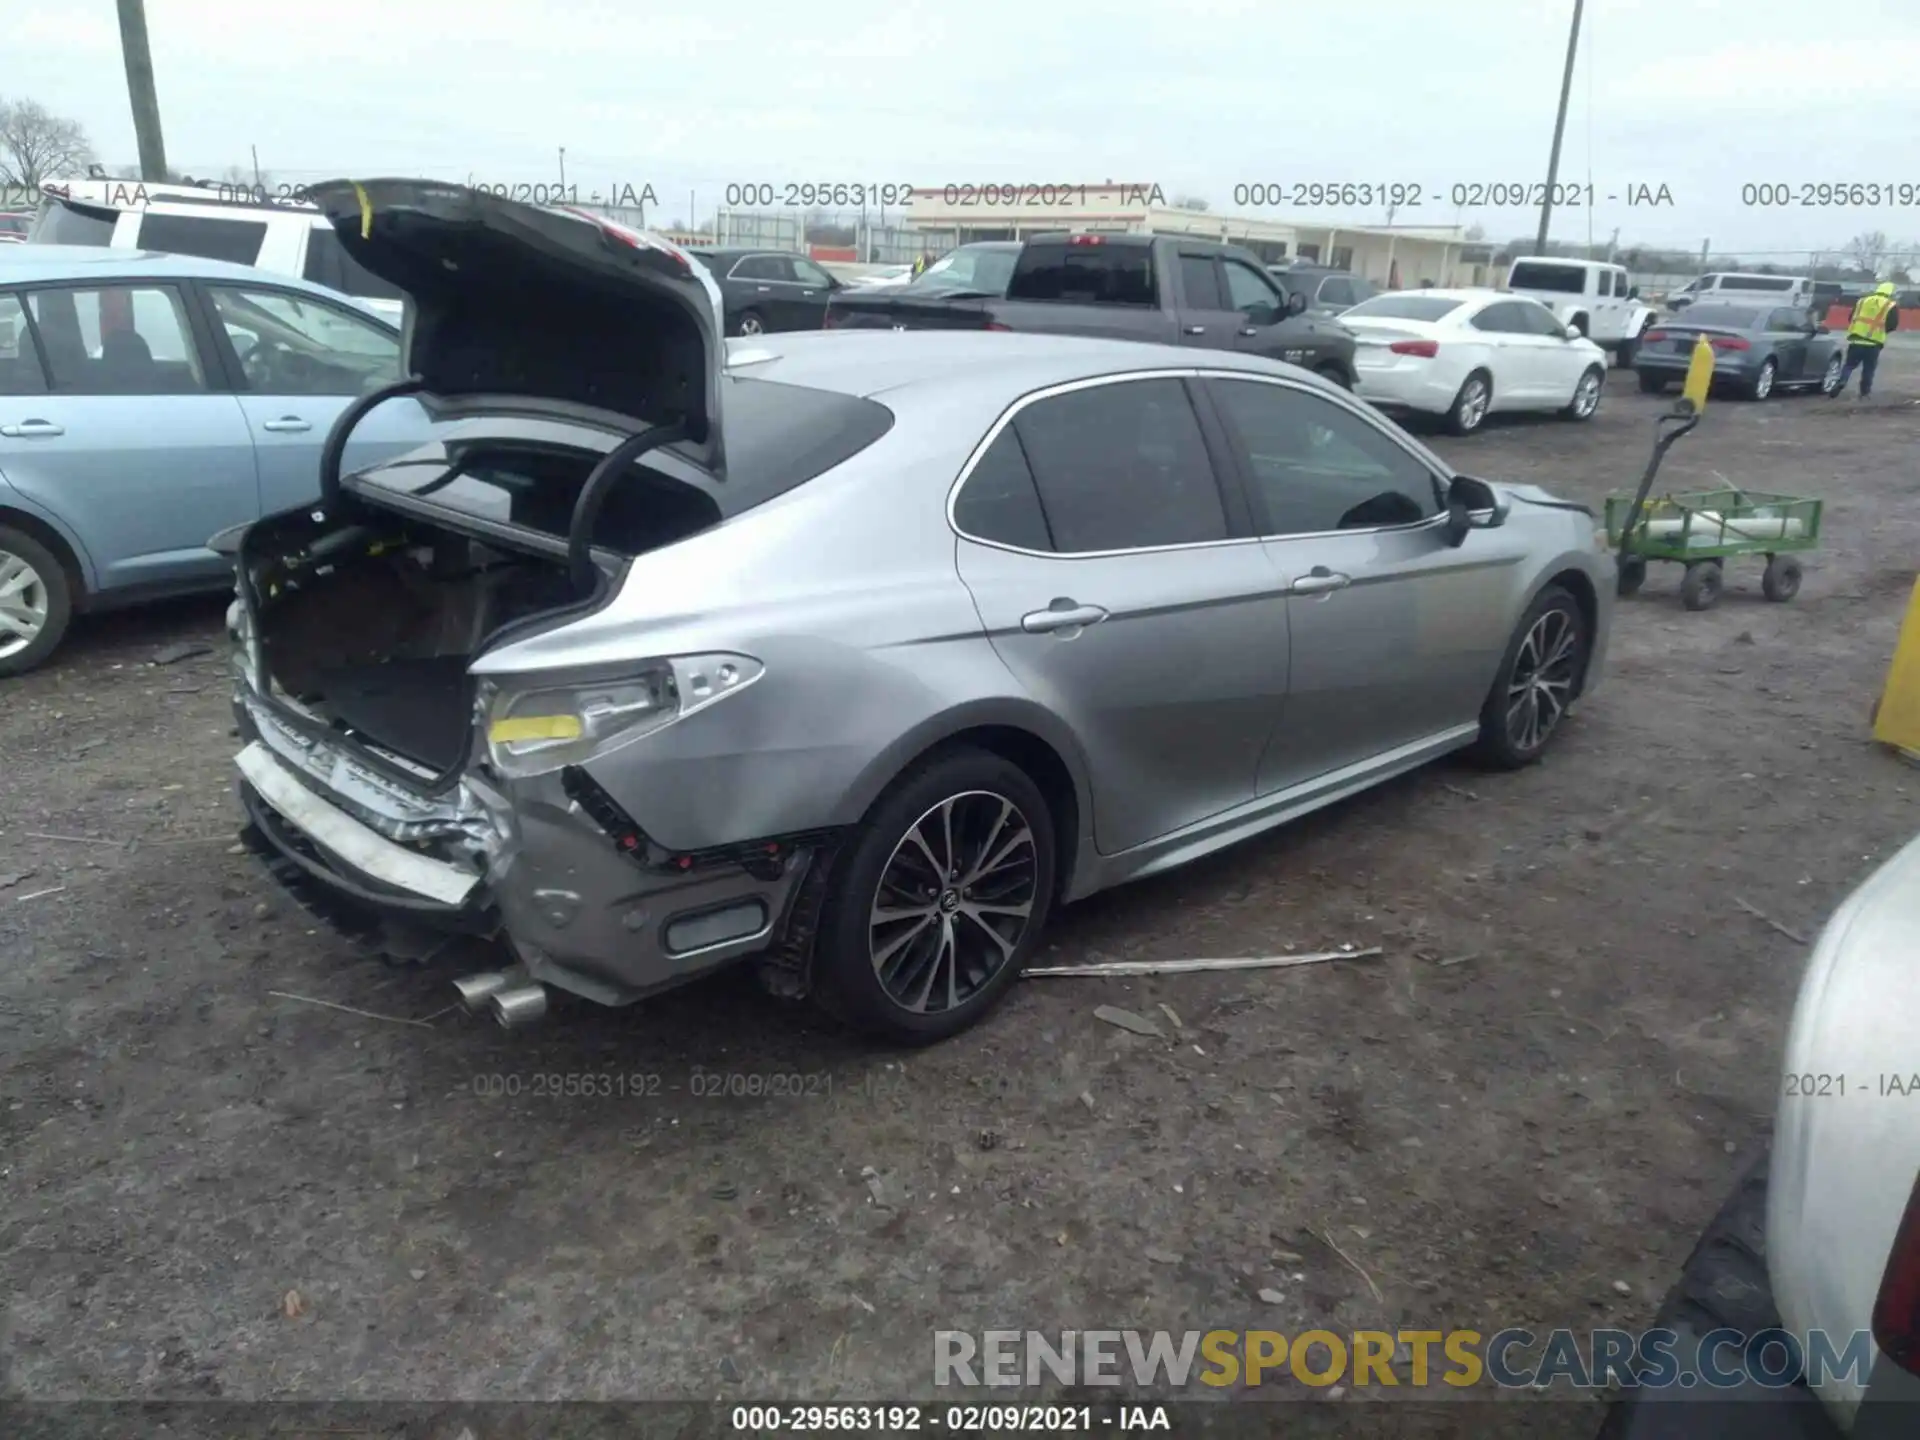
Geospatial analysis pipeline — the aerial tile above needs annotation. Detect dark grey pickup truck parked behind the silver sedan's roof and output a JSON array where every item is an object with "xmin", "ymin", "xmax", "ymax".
[{"xmin": 826, "ymin": 234, "xmax": 1354, "ymax": 388}]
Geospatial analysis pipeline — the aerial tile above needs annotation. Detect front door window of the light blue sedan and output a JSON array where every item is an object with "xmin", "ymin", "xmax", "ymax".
[{"xmin": 207, "ymin": 286, "xmax": 399, "ymax": 396}]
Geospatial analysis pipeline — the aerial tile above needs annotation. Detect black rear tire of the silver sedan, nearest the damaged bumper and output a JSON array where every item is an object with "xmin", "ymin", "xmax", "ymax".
[{"xmin": 814, "ymin": 747, "xmax": 1056, "ymax": 1044}]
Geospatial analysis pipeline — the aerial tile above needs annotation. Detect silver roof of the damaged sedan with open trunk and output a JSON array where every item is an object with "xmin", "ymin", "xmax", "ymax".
[{"xmin": 730, "ymin": 330, "xmax": 1327, "ymax": 399}]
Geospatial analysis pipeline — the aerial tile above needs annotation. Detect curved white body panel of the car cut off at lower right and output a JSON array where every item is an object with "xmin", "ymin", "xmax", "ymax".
[{"xmin": 1766, "ymin": 837, "xmax": 1920, "ymax": 1415}]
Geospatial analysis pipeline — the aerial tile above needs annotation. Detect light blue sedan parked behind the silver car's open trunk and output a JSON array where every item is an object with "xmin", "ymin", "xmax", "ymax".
[{"xmin": 0, "ymin": 244, "xmax": 432, "ymax": 676}]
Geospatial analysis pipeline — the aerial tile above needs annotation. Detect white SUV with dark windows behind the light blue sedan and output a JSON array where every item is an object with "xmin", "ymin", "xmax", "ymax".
[{"xmin": 27, "ymin": 180, "xmax": 401, "ymax": 324}]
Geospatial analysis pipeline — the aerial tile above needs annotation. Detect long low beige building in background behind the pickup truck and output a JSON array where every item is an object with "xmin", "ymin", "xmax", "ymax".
[{"xmin": 906, "ymin": 180, "xmax": 1498, "ymax": 288}]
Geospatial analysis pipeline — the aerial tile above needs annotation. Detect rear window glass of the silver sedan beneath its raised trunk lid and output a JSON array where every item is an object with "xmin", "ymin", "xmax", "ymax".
[{"xmin": 355, "ymin": 378, "xmax": 893, "ymax": 555}]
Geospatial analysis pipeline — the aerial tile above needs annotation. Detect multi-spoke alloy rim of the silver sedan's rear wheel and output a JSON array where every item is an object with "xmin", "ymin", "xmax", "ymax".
[{"xmin": 868, "ymin": 791, "xmax": 1039, "ymax": 1014}]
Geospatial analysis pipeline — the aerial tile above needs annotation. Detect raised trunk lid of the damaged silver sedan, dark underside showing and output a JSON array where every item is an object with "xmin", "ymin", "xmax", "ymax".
[{"xmin": 309, "ymin": 179, "xmax": 726, "ymax": 474}]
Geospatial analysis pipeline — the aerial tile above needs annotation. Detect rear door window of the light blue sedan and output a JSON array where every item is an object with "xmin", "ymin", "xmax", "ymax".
[{"xmin": 27, "ymin": 284, "xmax": 207, "ymax": 396}]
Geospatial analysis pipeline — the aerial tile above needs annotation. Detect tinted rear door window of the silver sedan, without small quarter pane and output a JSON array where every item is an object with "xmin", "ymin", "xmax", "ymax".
[{"xmin": 1012, "ymin": 378, "xmax": 1227, "ymax": 555}]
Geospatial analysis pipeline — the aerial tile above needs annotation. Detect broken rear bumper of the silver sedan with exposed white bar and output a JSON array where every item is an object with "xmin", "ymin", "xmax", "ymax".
[{"xmin": 234, "ymin": 695, "xmax": 812, "ymax": 1004}]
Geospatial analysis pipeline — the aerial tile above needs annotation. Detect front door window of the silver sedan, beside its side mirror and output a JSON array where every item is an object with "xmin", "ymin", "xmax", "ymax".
[{"xmin": 1208, "ymin": 380, "xmax": 1440, "ymax": 536}]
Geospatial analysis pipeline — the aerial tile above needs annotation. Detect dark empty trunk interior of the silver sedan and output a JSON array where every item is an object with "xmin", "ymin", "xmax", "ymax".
[{"xmin": 257, "ymin": 522, "xmax": 578, "ymax": 776}]
